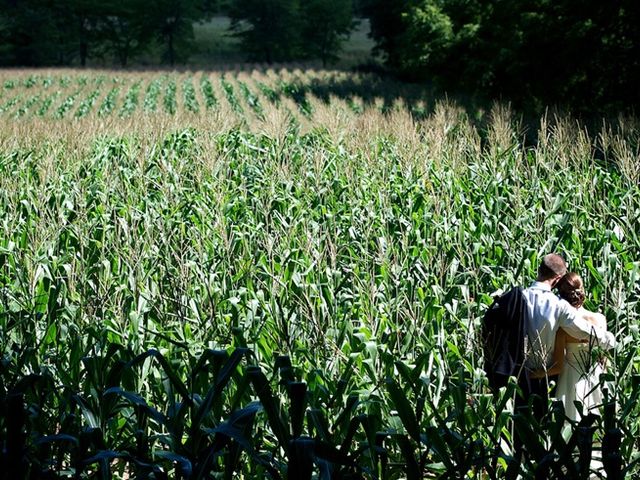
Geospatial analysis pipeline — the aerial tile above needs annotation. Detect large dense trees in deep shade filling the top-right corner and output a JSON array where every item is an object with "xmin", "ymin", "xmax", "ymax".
[{"xmin": 365, "ymin": 0, "xmax": 640, "ymax": 113}]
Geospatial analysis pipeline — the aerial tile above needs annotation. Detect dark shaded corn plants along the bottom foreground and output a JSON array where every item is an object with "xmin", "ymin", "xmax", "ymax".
[{"xmin": 0, "ymin": 344, "xmax": 624, "ymax": 479}]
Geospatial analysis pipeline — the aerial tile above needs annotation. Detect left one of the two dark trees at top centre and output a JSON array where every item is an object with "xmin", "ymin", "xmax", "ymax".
[{"xmin": 229, "ymin": 0, "xmax": 300, "ymax": 63}]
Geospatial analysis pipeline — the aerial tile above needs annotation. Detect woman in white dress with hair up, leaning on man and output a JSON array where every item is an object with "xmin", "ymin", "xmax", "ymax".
[{"xmin": 533, "ymin": 272, "xmax": 607, "ymax": 421}]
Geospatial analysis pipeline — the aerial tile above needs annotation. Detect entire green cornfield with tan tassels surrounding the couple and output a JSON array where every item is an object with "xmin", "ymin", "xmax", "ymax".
[{"xmin": 0, "ymin": 67, "xmax": 640, "ymax": 479}]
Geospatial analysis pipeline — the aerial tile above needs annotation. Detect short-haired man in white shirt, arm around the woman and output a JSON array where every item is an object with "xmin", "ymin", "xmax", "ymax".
[{"xmin": 516, "ymin": 253, "xmax": 615, "ymax": 412}]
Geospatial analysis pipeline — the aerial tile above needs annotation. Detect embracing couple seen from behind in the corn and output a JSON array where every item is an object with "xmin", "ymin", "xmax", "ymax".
[{"xmin": 516, "ymin": 253, "xmax": 615, "ymax": 420}]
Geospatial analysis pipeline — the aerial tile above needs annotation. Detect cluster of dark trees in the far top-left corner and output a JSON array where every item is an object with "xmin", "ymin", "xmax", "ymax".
[{"xmin": 0, "ymin": 0, "xmax": 207, "ymax": 66}]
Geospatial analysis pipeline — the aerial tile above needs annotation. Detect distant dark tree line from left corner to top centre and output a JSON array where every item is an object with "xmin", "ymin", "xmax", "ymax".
[{"xmin": 0, "ymin": 0, "xmax": 355, "ymax": 67}]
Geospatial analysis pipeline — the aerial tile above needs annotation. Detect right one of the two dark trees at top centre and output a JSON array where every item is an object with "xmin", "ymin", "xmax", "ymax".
[{"xmin": 301, "ymin": 0, "xmax": 355, "ymax": 66}]
